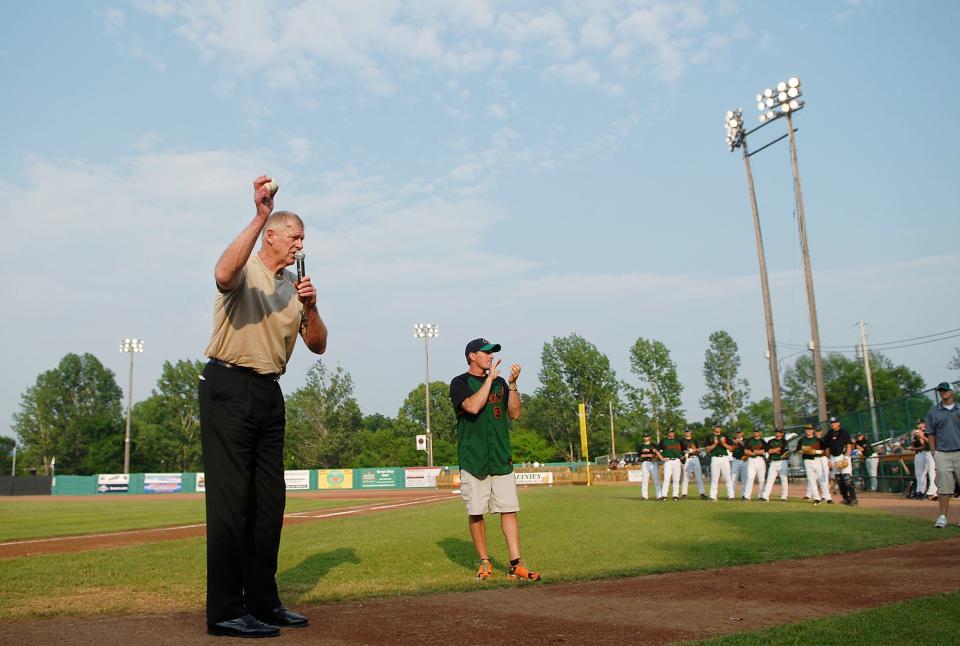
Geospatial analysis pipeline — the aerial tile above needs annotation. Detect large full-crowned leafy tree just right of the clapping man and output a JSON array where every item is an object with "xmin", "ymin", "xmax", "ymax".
[{"xmin": 522, "ymin": 334, "xmax": 620, "ymax": 460}]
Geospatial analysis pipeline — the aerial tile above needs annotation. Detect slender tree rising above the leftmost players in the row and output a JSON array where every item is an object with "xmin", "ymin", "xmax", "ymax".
[{"xmin": 630, "ymin": 337, "xmax": 686, "ymax": 442}]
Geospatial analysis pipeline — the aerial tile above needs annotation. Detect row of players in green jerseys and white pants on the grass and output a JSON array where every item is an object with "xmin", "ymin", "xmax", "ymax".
[{"xmin": 629, "ymin": 417, "xmax": 879, "ymax": 506}]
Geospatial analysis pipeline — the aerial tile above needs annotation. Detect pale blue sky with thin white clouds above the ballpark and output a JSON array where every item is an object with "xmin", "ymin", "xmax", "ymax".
[{"xmin": 0, "ymin": 0, "xmax": 960, "ymax": 440}]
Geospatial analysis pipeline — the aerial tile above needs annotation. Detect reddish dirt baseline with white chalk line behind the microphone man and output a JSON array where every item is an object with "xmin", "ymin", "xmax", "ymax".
[{"xmin": 0, "ymin": 489, "xmax": 458, "ymax": 559}]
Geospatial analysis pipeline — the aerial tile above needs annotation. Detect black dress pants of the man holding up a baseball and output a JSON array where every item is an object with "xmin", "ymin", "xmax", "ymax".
[{"xmin": 198, "ymin": 363, "xmax": 286, "ymax": 623}]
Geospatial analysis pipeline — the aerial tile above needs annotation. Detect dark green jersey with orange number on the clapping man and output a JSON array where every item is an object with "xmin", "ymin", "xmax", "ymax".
[{"xmin": 450, "ymin": 372, "xmax": 513, "ymax": 478}]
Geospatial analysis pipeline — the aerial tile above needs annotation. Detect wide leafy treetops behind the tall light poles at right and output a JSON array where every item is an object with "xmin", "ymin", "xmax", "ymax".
[{"xmin": 783, "ymin": 352, "xmax": 924, "ymax": 417}]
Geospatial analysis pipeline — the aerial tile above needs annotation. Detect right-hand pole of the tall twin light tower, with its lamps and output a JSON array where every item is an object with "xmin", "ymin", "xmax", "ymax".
[{"xmin": 757, "ymin": 76, "xmax": 827, "ymax": 424}]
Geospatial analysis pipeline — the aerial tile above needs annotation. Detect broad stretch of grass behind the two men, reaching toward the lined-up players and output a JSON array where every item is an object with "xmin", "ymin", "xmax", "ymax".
[{"xmin": 0, "ymin": 487, "xmax": 940, "ymax": 620}]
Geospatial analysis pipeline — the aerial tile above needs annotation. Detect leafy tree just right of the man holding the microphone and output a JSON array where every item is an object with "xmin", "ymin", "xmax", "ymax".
[{"xmin": 284, "ymin": 359, "xmax": 363, "ymax": 469}]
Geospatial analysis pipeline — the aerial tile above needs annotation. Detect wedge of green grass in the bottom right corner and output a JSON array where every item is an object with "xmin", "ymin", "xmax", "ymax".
[{"xmin": 689, "ymin": 593, "xmax": 960, "ymax": 646}]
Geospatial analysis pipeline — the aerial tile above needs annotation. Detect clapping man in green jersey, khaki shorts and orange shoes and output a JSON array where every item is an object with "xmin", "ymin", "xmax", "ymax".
[{"xmin": 450, "ymin": 339, "xmax": 540, "ymax": 581}]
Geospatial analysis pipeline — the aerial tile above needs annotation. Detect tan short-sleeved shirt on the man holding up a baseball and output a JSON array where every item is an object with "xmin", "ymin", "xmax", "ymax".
[{"xmin": 206, "ymin": 253, "xmax": 303, "ymax": 374}]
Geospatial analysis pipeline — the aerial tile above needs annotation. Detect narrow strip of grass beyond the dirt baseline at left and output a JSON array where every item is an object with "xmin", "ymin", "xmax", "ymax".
[{"xmin": 0, "ymin": 496, "xmax": 376, "ymax": 542}]
